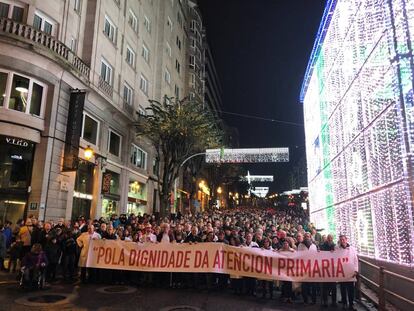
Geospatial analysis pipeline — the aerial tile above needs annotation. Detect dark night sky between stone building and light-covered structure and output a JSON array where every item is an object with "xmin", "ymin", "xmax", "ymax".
[{"xmin": 199, "ymin": 0, "xmax": 326, "ymax": 191}]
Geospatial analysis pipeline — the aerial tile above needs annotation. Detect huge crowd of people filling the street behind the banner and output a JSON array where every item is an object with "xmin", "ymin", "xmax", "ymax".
[{"xmin": 0, "ymin": 207, "xmax": 357, "ymax": 309}]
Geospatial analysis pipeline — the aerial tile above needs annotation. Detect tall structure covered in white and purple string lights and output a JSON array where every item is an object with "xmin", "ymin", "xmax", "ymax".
[{"xmin": 301, "ymin": 0, "xmax": 414, "ymax": 265}]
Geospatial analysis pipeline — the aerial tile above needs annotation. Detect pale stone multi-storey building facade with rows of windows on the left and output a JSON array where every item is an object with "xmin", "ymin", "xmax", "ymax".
[{"xmin": 0, "ymin": 0, "xmax": 220, "ymax": 223}]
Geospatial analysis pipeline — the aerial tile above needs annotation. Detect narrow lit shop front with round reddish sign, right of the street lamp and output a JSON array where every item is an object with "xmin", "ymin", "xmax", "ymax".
[{"xmin": 101, "ymin": 170, "xmax": 121, "ymax": 219}]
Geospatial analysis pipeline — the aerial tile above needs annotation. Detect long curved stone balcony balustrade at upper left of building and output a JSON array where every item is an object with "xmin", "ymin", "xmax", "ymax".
[{"xmin": 0, "ymin": 18, "xmax": 90, "ymax": 81}]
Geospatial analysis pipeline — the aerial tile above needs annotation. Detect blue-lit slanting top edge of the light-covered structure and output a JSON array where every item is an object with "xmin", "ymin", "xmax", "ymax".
[{"xmin": 299, "ymin": 0, "xmax": 338, "ymax": 103}]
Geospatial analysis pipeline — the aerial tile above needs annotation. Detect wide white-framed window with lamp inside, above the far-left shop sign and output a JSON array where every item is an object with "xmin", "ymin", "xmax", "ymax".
[{"xmin": 0, "ymin": 69, "xmax": 47, "ymax": 117}]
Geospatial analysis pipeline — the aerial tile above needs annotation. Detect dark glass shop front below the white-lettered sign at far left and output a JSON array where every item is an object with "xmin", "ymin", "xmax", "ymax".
[{"xmin": 0, "ymin": 135, "xmax": 35, "ymax": 224}]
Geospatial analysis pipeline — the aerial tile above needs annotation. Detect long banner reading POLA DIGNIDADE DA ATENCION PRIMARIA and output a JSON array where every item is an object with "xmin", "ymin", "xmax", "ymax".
[{"xmin": 86, "ymin": 240, "xmax": 358, "ymax": 282}]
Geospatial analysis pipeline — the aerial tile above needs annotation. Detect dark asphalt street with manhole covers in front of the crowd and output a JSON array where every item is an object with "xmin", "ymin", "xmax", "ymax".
[{"xmin": 0, "ymin": 272, "xmax": 365, "ymax": 311}]
